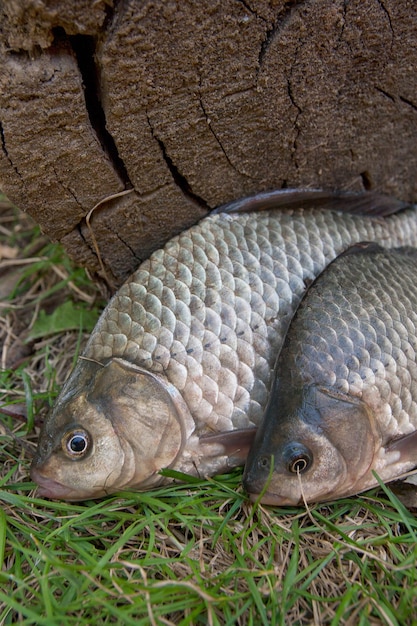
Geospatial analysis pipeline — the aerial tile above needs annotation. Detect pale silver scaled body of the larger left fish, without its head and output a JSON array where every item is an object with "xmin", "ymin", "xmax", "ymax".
[{"xmin": 84, "ymin": 209, "xmax": 417, "ymax": 434}]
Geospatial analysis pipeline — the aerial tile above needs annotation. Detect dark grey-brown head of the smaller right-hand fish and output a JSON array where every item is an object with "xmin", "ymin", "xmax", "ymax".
[{"xmin": 243, "ymin": 385, "xmax": 379, "ymax": 506}]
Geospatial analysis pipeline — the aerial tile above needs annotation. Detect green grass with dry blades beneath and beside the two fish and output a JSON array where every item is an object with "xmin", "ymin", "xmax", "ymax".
[{"xmin": 0, "ymin": 194, "xmax": 417, "ymax": 626}]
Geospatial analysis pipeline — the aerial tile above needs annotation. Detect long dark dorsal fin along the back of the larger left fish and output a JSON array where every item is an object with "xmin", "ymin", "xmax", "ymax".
[{"xmin": 212, "ymin": 189, "xmax": 410, "ymax": 217}]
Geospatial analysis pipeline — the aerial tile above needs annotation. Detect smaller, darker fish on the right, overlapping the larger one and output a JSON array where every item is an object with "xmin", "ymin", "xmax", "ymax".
[{"xmin": 243, "ymin": 242, "xmax": 417, "ymax": 506}]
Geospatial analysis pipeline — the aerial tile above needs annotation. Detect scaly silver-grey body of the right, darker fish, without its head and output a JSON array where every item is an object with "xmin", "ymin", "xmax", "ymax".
[{"xmin": 281, "ymin": 251, "xmax": 417, "ymax": 441}]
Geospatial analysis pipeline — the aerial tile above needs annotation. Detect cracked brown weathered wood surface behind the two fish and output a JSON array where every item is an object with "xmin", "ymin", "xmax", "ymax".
[{"xmin": 0, "ymin": 0, "xmax": 417, "ymax": 284}]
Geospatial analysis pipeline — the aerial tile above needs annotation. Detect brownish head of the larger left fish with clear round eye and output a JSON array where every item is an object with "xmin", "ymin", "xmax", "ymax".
[{"xmin": 31, "ymin": 359, "xmax": 193, "ymax": 500}]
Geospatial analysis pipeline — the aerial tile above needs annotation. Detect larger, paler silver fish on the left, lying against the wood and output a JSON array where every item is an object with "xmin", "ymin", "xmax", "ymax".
[{"xmin": 31, "ymin": 190, "xmax": 417, "ymax": 500}]
